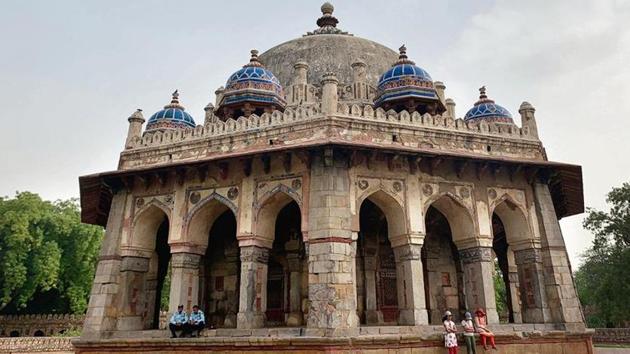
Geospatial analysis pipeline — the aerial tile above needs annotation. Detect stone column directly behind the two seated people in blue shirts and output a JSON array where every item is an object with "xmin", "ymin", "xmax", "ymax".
[{"xmin": 168, "ymin": 253, "xmax": 200, "ymax": 313}]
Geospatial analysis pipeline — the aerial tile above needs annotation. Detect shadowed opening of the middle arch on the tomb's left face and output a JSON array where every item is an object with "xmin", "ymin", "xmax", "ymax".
[{"xmin": 204, "ymin": 210, "xmax": 241, "ymax": 328}]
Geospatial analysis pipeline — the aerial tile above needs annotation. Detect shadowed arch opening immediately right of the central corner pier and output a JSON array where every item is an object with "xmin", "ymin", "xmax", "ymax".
[{"xmin": 356, "ymin": 199, "xmax": 398, "ymax": 325}]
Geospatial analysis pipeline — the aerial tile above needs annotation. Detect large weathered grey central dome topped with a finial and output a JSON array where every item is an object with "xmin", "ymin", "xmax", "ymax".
[{"xmin": 260, "ymin": 4, "xmax": 398, "ymax": 86}]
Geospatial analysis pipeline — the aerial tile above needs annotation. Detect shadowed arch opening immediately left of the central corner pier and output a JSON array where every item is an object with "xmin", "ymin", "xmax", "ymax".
[{"xmin": 265, "ymin": 200, "xmax": 308, "ymax": 327}]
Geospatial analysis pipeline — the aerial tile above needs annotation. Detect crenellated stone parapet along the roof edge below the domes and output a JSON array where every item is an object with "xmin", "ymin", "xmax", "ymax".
[{"xmin": 128, "ymin": 103, "xmax": 538, "ymax": 149}]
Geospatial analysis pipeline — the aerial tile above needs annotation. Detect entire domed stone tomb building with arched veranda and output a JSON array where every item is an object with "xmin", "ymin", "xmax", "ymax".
[{"xmin": 74, "ymin": 3, "xmax": 592, "ymax": 353}]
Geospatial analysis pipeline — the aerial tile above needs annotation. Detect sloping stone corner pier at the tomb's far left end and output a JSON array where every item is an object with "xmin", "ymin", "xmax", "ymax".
[{"xmin": 81, "ymin": 192, "xmax": 127, "ymax": 339}]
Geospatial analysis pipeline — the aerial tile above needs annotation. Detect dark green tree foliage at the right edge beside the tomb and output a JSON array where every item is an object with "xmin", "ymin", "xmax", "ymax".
[{"xmin": 575, "ymin": 183, "xmax": 630, "ymax": 327}]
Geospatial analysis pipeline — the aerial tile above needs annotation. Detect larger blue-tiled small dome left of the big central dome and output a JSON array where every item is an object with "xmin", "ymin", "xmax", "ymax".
[{"xmin": 221, "ymin": 50, "xmax": 285, "ymax": 107}]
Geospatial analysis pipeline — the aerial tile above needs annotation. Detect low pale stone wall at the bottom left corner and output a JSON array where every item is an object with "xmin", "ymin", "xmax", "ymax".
[{"xmin": 0, "ymin": 337, "xmax": 76, "ymax": 354}]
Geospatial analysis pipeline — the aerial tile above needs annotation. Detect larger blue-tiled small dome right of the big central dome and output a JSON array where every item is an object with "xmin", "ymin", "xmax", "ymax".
[{"xmin": 374, "ymin": 46, "xmax": 439, "ymax": 106}]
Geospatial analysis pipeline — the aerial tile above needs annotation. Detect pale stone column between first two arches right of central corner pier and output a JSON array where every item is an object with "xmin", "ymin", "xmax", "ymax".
[{"xmin": 394, "ymin": 244, "xmax": 429, "ymax": 325}]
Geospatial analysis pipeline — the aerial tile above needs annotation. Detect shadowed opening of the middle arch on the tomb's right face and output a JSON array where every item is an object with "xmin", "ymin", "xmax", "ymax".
[{"xmin": 421, "ymin": 207, "xmax": 466, "ymax": 324}]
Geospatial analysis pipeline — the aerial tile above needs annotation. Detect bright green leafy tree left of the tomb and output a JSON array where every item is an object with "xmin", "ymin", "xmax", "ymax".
[{"xmin": 0, "ymin": 192, "xmax": 103, "ymax": 313}]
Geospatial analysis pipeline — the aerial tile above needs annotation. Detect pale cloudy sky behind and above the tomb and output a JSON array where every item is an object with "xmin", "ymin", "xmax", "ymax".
[{"xmin": 0, "ymin": 0, "xmax": 630, "ymax": 266}]
